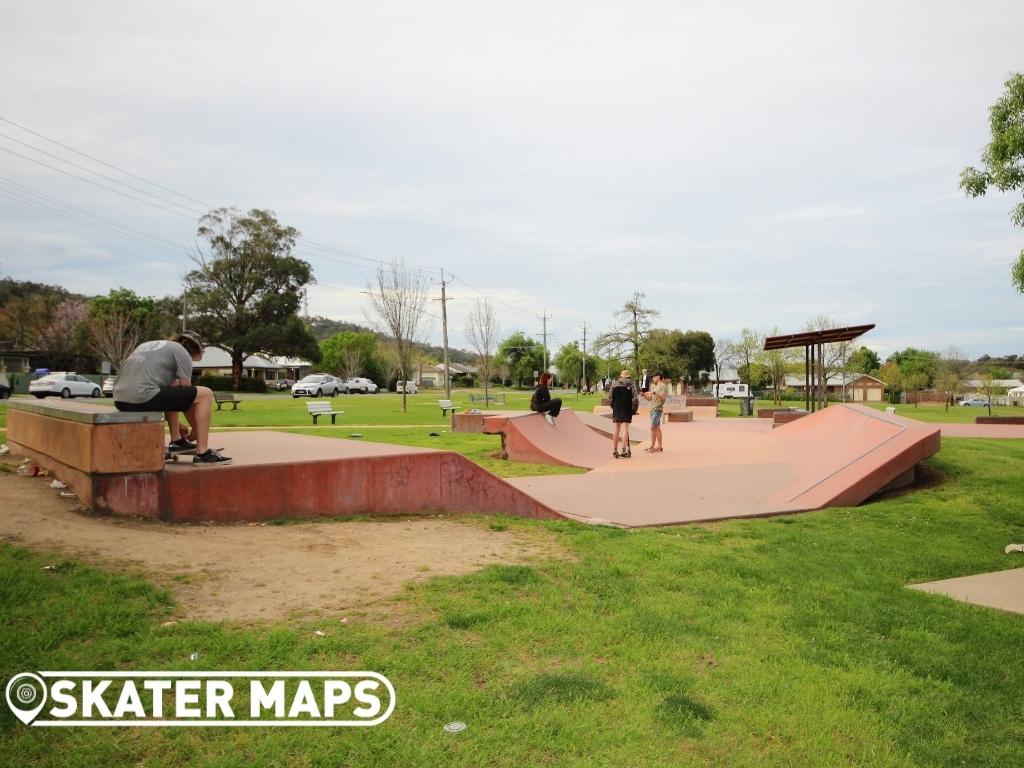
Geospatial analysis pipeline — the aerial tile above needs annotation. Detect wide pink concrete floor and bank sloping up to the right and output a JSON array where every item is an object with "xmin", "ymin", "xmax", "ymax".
[{"xmin": 511, "ymin": 406, "xmax": 939, "ymax": 527}]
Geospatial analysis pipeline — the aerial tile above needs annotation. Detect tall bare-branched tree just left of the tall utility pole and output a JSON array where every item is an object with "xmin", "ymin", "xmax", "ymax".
[{"xmin": 367, "ymin": 260, "xmax": 431, "ymax": 412}]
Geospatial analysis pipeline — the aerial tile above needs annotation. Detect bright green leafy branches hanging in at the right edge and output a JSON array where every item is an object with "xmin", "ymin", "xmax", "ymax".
[{"xmin": 959, "ymin": 73, "xmax": 1024, "ymax": 293}]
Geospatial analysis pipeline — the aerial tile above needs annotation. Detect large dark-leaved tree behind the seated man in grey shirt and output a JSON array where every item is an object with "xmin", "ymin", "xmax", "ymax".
[{"xmin": 185, "ymin": 208, "xmax": 319, "ymax": 389}]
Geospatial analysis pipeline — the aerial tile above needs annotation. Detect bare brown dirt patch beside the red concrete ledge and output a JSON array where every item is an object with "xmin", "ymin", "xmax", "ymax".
[{"xmin": 0, "ymin": 467, "xmax": 564, "ymax": 622}]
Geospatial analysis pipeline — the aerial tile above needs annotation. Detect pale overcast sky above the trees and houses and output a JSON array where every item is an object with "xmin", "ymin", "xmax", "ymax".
[{"xmin": 0, "ymin": 0, "xmax": 1024, "ymax": 356}]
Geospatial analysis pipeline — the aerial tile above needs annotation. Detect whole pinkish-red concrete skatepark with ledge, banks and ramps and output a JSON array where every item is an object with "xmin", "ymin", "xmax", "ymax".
[{"xmin": 2, "ymin": 391, "xmax": 940, "ymax": 527}]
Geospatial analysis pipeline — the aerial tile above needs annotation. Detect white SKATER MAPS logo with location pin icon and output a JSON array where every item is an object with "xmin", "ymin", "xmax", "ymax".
[{"xmin": 4, "ymin": 672, "xmax": 395, "ymax": 728}]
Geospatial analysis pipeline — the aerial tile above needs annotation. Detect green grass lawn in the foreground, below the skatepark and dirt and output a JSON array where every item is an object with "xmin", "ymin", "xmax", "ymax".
[{"xmin": 0, "ymin": 439, "xmax": 1024, "ymax": 768}]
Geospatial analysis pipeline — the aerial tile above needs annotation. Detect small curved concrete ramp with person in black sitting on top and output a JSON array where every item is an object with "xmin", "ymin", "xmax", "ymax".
[{"xmin": 483, "ymin": 408, "xmax": 611, "ymax": 469}]
